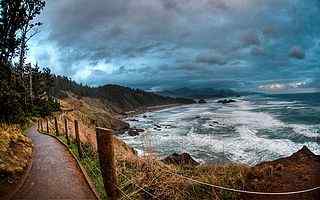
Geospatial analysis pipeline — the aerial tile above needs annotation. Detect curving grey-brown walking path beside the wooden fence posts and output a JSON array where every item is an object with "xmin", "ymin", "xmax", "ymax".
[{"xmin": 12, "ymin": 128, "xmax": 96, "ymax": 199}]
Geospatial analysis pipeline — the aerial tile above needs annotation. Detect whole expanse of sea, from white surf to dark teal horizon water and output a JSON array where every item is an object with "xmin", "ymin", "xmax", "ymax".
[{"xmin": 121, "ymin": 93, "xmax": 320, "ymax": 165}]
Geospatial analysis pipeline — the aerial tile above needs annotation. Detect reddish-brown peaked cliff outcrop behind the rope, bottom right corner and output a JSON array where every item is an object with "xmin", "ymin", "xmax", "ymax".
[{"xmin": 243, "ymin": 147, "xmax": 320, "ymax": 200}]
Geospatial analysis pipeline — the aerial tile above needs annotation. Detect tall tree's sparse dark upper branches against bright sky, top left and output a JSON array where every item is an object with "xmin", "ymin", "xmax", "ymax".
[{"xmin": 0, "ymin": 0, "xmax": 45, "ymax": 64}]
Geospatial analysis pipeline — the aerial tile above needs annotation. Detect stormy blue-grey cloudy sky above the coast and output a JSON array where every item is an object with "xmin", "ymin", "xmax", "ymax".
[{"xmin": 29, "ymin": 0, "xmax": 320, "ymax": 91}]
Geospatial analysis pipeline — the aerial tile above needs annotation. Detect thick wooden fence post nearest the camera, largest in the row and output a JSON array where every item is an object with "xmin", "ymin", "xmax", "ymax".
[{"xmin": 96, "ymin": 127, "xmax": 119, "ymax": 200}]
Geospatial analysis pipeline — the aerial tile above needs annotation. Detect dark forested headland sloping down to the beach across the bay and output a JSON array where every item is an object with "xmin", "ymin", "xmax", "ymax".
[{"xmin": 53, "ymin": 76, "xmax": 195, "ymax": 113}]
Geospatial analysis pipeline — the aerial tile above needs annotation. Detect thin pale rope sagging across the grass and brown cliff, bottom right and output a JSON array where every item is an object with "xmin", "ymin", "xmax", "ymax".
[{"xmin": 167, "ymin": 171, "xmax": 320, "ymax": 195}]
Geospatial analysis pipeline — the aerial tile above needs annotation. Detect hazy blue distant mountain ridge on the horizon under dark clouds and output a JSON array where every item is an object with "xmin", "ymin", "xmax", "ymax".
[{"xmin": 158, "ymin": 88, "xmax": 242, "ymax": 99}]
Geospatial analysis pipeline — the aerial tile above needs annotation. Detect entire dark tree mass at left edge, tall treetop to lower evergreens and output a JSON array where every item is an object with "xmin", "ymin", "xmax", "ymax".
[{"xmin": 0, "ymin": 0, "xmax": 59, "ymax": 123}]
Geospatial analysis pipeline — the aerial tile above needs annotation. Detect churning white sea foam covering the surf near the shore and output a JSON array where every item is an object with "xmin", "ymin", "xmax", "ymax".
[{"xmin": 122, "ymin": 96, "xmax": 320, "ymax": 164}]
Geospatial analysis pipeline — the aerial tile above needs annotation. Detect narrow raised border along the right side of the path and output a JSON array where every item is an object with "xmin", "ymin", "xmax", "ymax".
[{"xmin": 38, "ymin": 131, "xmax": 101, "ymax": 200}]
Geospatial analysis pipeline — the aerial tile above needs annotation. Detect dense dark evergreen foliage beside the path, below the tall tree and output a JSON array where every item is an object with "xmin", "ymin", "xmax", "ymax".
[{"xmin": 0, "ymin": 62, "xmax": 59, "ymax": 123}]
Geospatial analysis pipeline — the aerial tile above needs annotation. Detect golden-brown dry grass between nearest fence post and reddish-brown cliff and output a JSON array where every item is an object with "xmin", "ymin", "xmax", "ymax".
[{"xmin": 117, "ymin": 154, "xmax": 249, "ymax": 200}]
